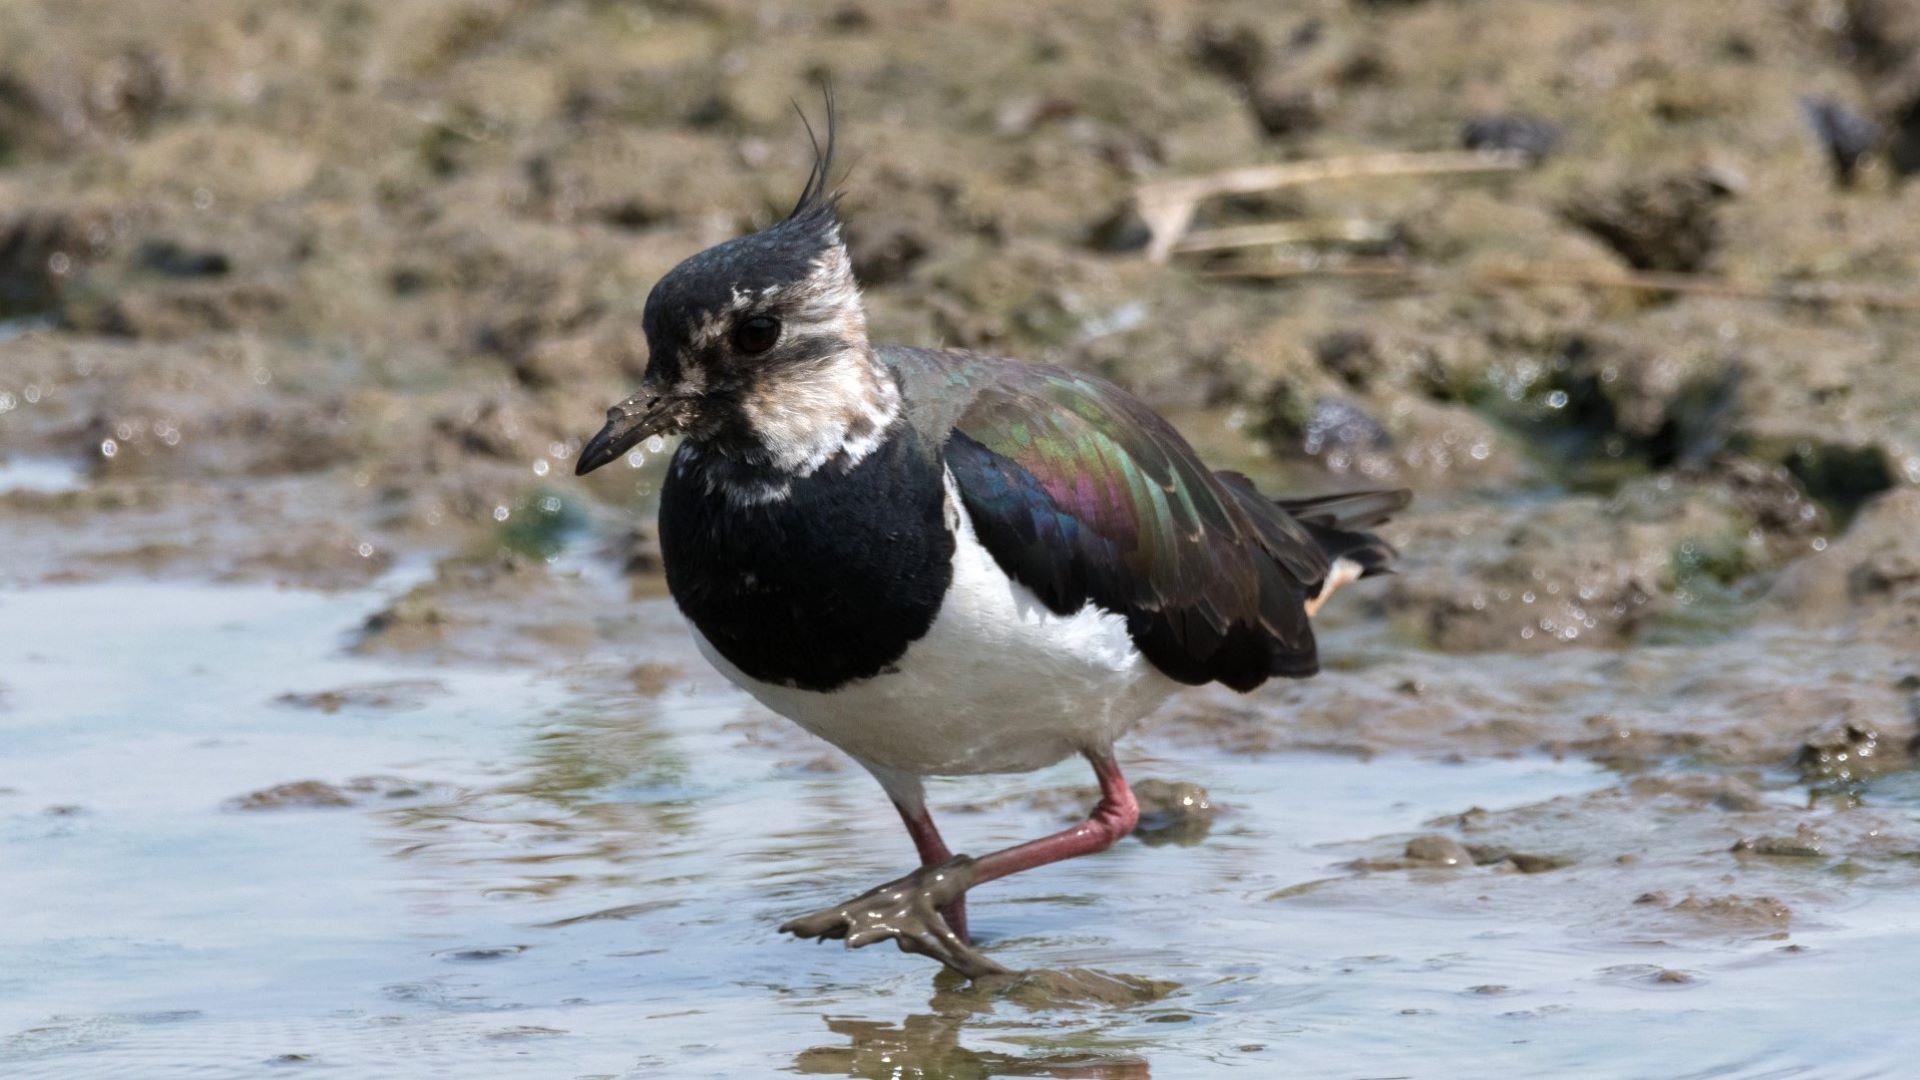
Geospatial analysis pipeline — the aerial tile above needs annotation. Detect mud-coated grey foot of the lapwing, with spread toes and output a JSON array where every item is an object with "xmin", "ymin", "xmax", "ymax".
[{"xmin": 780, "ymin": 855, "xmax": 1012, "ymax": 978}]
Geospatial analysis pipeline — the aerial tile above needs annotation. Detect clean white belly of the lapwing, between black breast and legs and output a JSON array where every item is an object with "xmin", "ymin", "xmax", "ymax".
[{"xmin": 693, "ymin": 477, "xmax": 1179, "ymax": 776}]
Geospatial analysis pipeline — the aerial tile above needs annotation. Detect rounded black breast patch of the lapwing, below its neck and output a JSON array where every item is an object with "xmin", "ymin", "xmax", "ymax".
[{"xmin": 660, "ymin": 425, "xmax": 954, "ymax": 690}]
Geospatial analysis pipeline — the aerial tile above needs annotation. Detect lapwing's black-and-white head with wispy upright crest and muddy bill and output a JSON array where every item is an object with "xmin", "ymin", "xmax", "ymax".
[{"xmin": 576, "ymin": 98, "xmax": 899, "ymax": 475}]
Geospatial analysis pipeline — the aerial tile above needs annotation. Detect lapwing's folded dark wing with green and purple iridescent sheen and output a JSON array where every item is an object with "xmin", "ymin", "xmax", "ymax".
[{"xmin": 943, "ymin": 357, "xmax": 1327, "ymax": 690}]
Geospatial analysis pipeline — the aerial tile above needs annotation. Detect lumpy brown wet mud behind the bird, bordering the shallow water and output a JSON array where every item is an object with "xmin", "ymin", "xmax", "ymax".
[{"xmin": 11, "ymin": 0, "xmax": 1920, "ymax": 1072}]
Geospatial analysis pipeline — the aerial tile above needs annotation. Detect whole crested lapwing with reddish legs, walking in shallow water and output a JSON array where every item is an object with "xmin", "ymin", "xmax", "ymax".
[{"xmin": 576, "ymin": 102, "xmax": 1411, "ymax": 978}]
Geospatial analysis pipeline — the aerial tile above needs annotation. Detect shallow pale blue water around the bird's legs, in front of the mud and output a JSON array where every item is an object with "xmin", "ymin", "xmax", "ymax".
[{"xmin": 0, "ymin": 578, "xmax": 1920, "ymax": 1078}]
